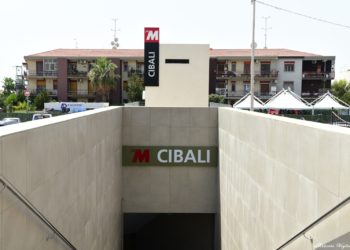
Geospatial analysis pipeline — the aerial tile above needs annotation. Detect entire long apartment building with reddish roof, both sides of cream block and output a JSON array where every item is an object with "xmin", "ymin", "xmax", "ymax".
[{"xmin": 23, "ymin": 49, "xmax": 335, "ymax": 104}]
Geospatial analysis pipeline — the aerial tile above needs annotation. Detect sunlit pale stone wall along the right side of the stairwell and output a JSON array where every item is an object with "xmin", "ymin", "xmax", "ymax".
[{"xmin": 219, "ymin": 108, "xmax": 350, "ymax": 250}]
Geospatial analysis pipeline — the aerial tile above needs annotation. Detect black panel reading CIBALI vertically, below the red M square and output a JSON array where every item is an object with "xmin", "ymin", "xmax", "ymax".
[{"xmin": 145, "ymin": 43, "xmax": 159, "ymax": 87}]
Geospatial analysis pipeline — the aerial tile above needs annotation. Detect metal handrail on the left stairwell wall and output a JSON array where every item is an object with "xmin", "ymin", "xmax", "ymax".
[{"xmin": 0, "ymin": 174, "xmax": 76, "ymax": 250}]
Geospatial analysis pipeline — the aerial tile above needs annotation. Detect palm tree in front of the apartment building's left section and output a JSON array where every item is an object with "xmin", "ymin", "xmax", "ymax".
[{"xmin": 89, "ymin": 57, "xmax": 120, "ymax": 102}]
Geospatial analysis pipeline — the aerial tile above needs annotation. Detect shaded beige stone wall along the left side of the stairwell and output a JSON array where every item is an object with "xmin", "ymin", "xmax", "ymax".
[{"xmin": 0, "ymin": 108, "xmax": 122, "ymax": 250}]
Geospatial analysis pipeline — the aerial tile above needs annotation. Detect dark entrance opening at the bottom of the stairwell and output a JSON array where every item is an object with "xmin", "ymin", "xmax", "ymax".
[{"xmin": 123, "ymin": 213, "xmax": 215, "ymax": 250}]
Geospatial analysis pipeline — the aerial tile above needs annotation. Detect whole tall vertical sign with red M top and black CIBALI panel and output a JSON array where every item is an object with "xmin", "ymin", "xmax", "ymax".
[{"xmin": 145, "ymin": 28, "xmax": 159, "ymax": 87}]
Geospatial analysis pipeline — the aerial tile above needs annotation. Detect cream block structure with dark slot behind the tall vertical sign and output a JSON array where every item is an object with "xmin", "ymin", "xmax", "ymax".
[{"xmin": 145, "ymin": 44, "xmax": 210, "ymax": 107}]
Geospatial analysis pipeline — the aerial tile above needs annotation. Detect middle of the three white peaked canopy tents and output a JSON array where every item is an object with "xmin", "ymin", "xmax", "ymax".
[{"xmin": 265, "ymin": 88, "xmax": 311, "ymax": 110}]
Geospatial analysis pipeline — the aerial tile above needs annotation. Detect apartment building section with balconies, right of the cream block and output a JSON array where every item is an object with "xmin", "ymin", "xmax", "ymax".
[{"xmin": 209, "ymin": 49, "xmax": 335, "ymax": 104}]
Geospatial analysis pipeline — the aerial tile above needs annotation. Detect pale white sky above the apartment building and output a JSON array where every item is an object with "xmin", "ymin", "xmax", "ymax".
[{"xmin": 0, "ymin": 0, "xmax": 350, "ymax": 85}]
